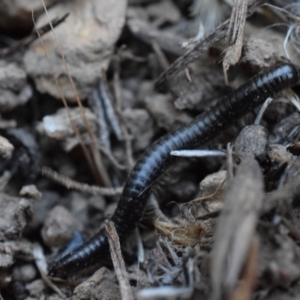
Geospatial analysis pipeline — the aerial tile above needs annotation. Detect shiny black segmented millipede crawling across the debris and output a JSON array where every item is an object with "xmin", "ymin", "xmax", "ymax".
[{"xmin": 49, "ymin": 63, "xmax": 300, "ymax": 276}]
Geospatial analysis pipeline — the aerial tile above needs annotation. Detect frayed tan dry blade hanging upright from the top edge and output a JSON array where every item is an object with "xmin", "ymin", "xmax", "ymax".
[{"xmin": 223, "ymin": 0, "xmax": 247, "ymax": 84}]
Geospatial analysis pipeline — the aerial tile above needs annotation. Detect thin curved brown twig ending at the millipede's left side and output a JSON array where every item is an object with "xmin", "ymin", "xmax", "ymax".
[{"xmin": 41, "ymin": 166, "xmax": 123, "ymax": 196}]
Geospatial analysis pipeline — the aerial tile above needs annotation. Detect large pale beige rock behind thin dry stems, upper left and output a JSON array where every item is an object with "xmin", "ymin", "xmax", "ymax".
[{"xmin": 24, "ymin": 0, "xmax": 127, "ymax": 102}]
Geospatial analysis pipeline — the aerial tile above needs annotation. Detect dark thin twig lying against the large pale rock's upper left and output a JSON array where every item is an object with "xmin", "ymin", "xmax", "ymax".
[{"xmin": 0, "ymin": 13, "xmax": 69, "ymax": 58}]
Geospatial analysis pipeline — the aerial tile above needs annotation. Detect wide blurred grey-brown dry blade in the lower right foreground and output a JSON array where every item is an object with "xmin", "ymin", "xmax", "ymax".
[{"xmin": 210, "ymin": 156, "xmax": 263, "ymax": 300}]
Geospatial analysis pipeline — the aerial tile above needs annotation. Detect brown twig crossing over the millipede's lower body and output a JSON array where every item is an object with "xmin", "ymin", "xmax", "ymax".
[{"xmin": 104, "ymin": 220, "xmax": 134, "ymax": 300}]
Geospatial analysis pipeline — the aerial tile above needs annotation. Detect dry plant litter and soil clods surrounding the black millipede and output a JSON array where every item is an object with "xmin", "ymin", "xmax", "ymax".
[{"xmin": 0, "ymin": 0, "xmax": 300, "ymax": 300}]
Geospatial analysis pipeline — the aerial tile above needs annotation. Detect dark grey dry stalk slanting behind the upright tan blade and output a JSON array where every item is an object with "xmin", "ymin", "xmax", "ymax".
[{"xmin": 156, "ymin": 0, "xmax": 262, "ymax": 89}]
